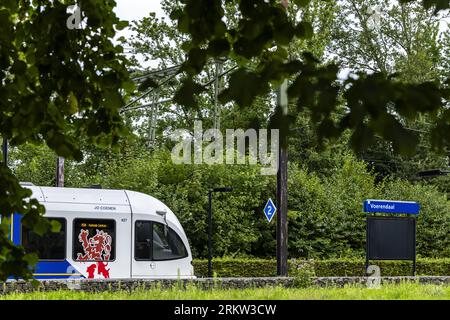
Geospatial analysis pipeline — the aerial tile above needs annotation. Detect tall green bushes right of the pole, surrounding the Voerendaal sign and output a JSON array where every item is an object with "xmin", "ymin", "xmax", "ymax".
[{"xmin": 288, "ymin": 156, "xmax": 450, "ymax": 259}]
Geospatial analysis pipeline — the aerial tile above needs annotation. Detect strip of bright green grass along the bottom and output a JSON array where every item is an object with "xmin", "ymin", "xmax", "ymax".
[{"xmin": 0, "ymin": 283, "xmax": 450, "ymax": 300}]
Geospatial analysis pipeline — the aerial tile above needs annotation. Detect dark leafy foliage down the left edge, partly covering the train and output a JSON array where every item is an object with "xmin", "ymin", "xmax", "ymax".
[{"xmin": 0, "ymin": 0, "xmax": 133, "ymax": 280}]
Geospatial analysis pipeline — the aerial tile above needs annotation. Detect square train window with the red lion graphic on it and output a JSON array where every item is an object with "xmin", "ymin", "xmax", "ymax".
[{"xmin": 73, "ymin": 219, "xmax": 116, "ymax": 261}]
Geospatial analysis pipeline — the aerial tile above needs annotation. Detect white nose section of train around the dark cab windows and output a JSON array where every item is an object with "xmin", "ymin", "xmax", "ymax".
[{"xmin": 132, "ymin": 214, "xmax": 191, "ymax": 278}]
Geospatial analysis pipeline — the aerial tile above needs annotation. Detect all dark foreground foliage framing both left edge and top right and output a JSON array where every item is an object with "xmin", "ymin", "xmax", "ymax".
[{"xmin": 0, "ymin": 0, "xmax": 450, "ymax": 278}]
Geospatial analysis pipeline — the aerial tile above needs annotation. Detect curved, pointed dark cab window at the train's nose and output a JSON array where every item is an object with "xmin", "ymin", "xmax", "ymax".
[{"xmin": 152, "ymin": 222, "xmax": 188, "ymax": 260}]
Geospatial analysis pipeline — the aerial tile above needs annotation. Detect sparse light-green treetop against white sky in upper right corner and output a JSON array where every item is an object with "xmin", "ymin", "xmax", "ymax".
[{"xmin": 328, "ymin": 0, "xmax": 448, "ymax": 83}]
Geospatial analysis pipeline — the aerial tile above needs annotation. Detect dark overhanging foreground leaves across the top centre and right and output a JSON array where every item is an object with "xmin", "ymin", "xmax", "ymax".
[{"xmin": 171, "ymin": 0, "xmax": 449, "ymax": 153}]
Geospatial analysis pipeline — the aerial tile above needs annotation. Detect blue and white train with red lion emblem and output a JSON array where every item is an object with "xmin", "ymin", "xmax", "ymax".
[{"xmin": 10, "ymin": 185, "xmax": 194, "ymax": 279}]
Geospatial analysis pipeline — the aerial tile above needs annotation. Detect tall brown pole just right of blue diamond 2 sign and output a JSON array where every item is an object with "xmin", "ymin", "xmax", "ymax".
[{"xmin": 277, "ymin": 80, "xmax": 288, "ymax": 277}]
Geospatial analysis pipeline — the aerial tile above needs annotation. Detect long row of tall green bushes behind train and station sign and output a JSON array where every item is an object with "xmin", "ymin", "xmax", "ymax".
[{"xmin": 12, "ymin": 142, "xmax": 450, "ymax": 260}]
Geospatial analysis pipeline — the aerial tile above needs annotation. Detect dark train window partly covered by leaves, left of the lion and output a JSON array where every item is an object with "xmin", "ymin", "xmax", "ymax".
[{"xmin": 22, "ymin": 218, "xmax": 66, "ymax": 260}]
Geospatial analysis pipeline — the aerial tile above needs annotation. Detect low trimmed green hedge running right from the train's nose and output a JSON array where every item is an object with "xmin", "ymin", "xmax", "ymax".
[{"xmin": 193, "ymin": 258, "xmax": 450, "ymax": 277}]
